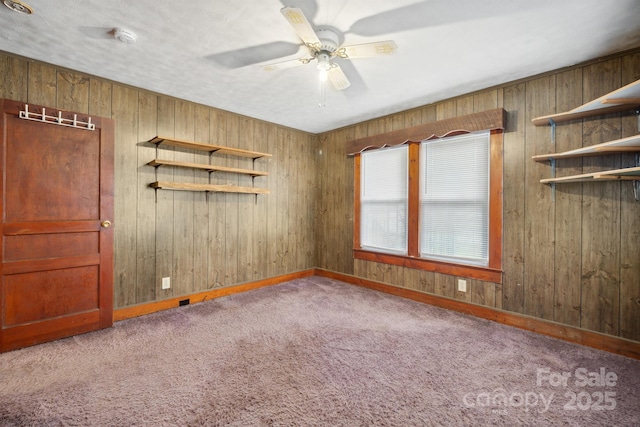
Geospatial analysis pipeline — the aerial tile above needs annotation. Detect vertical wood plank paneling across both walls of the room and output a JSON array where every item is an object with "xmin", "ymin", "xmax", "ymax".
[{"xmin": 0, "ymin": 50, "xmax": 640, "ymax": 341}]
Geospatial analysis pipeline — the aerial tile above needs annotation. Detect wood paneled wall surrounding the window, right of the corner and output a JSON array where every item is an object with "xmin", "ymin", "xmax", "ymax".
[{"xmin": 315, "ymin": 51, "xmax": 640, "ymax": 341}]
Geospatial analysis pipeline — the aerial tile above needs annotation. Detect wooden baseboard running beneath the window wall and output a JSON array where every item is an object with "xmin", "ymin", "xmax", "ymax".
[{"xmin": 315, "ymin": 268, "xmax": 640, "ymax": 360}]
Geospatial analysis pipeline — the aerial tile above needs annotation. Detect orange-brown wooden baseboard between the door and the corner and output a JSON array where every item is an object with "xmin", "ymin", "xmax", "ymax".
[{"xmin": 113, "ymin": 269, "xmax": 315, "ymax": 322}]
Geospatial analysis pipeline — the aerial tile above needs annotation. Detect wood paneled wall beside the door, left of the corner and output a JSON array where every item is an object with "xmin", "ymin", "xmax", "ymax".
[{"xmin": 0, "ymin": 53, "xmax": 317, "ymax": 308}]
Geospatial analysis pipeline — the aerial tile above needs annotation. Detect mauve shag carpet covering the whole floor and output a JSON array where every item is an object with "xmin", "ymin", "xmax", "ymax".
[{"xmin": 0, "ymin": 277, "xmax": 640, "ymax": 426}]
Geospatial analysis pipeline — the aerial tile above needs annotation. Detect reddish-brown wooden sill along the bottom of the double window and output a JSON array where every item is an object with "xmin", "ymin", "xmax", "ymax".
[{"xmin": 353, "ymin": 249, "xmax": 502, "ymax": 284}]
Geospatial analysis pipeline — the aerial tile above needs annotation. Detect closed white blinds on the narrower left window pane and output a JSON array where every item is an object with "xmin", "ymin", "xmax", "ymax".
[{"xmin": 360, "ymin": 145, "xmax": 408, "ymax": 254}]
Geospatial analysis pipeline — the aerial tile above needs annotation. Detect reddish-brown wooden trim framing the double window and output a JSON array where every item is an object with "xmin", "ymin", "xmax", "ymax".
[{"xmin": 353, "ymin": 122, "xmax": 503, "ymax": 283}]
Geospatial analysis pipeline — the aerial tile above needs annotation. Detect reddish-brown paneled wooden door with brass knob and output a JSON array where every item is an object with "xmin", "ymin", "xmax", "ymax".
[{"xmin": 0, "ymin": 100, "xmax": 114, "ymax": 352}]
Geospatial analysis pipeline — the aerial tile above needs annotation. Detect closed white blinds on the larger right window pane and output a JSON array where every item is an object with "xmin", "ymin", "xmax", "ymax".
[{"xmin": 420, "ymin": 132, "xmax": 489, "ymax": 266}]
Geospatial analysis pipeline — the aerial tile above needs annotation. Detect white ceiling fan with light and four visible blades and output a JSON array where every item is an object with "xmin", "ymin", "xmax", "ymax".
[{"xmin": 262, "ymin": 7, "xmax": 397, "ymax": 94}]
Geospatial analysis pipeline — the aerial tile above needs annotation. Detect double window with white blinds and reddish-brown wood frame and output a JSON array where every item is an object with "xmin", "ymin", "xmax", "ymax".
[{"xmin": 354, "ymin": 130, "xmax": 502, "ymax": 283}]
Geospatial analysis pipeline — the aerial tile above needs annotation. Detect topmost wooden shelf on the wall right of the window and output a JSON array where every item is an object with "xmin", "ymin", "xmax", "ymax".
[{"xmin": 532, "ymin": 80, "xmax": 640, "ymax": 126}]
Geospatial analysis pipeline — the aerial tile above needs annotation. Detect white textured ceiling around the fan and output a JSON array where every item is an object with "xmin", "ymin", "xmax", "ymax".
[{"xmin": 0, "ymin": 0, "xmax": 640, "ymax": 133}]
